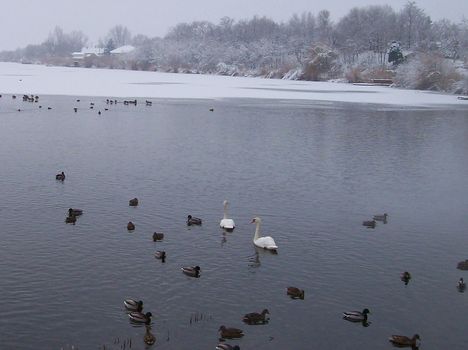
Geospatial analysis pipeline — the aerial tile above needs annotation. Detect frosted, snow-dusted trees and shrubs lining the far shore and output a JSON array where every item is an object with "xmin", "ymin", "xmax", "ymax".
[{"xmin": 0, "ymin": 1, "xmax": 468, "ymax": 93}]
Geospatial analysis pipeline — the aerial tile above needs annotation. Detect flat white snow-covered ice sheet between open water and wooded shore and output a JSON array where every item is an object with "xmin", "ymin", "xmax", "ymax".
[{"xmin": 0, "ymin": 62, "xmax": 468, "ymax": 108}]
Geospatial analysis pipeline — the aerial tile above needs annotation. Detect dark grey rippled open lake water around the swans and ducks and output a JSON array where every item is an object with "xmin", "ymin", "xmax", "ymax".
[{"xmin": 0, "ymin": 95, "xmax": 468, "ymax": 350}]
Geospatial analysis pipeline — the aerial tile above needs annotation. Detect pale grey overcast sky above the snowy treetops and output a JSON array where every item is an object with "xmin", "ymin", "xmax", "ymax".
[{"xmin": 0, "ymin": 0, "xmax": 468, "ymax": 50}]
